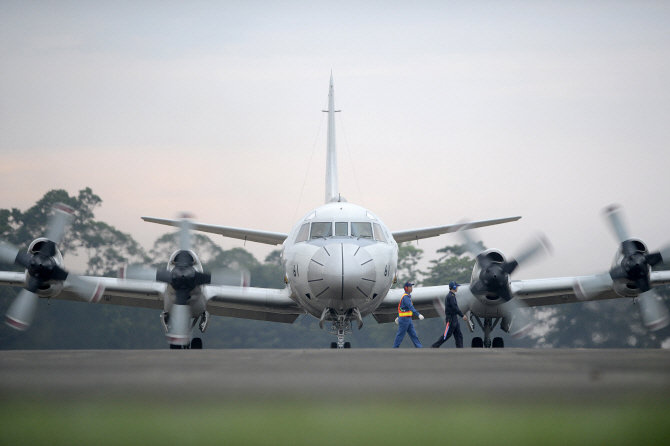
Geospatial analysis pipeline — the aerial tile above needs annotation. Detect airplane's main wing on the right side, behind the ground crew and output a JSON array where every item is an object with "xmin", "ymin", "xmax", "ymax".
[{"xmin": 373, "ymin": 271, "xmax": 670, "ymax": 324}]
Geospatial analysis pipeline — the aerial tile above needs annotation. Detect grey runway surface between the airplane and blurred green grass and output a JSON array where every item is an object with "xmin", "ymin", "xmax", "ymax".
[{"xmin": 0, "ymin": 349, "xmax": 670, "ymax": 402}]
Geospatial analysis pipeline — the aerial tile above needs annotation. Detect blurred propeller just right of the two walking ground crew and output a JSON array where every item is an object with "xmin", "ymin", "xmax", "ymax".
[{"xmin": 459, "ymin": 225, "xmax": 551, "ymax": 339}]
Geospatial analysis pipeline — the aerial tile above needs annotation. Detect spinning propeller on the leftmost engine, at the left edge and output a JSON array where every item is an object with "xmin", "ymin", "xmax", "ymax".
[{"xmin": 0, "ymin": 203, "xmax": 104, "ymax": 331}]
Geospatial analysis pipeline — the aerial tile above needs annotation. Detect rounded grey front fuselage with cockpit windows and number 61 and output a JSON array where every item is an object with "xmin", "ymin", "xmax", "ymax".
[{"xmin": 282, "ymin": 201, "xmax": 398, "ymax": 318}]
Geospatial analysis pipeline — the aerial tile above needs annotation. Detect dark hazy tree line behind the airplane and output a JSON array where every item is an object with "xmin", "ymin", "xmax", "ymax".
[{"xmin": 0, "ymin": 188, "xmax": 670, "ymax": 349}]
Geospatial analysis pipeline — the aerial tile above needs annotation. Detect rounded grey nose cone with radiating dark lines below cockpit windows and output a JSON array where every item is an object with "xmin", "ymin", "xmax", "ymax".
[{"xmin": 307, "ymin": 243, "xmax": 376, "ymax": 301}]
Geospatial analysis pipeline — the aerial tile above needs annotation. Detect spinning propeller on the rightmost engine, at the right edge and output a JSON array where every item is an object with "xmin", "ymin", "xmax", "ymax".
[{"xmin": 573, "ymin": 205, "xmax": 670, "ymax": 331}]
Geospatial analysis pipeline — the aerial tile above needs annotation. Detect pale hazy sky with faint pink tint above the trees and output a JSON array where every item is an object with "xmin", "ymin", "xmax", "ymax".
[{"xmin": 0, "ymin": 0, "xmax": 670, "ymax": 278}]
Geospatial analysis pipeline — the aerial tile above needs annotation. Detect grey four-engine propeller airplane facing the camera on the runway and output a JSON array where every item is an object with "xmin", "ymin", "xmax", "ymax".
[{"xmin": 0, "ymin": 74, "xmax": 670, "ymax": 348}]
